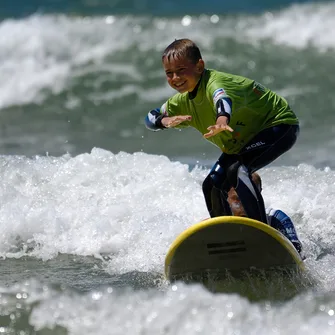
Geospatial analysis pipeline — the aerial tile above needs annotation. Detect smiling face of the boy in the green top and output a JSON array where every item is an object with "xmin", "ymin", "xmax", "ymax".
[{"xmin": 163, "ymin": 57, "xmax": 205, "ymax": 93}]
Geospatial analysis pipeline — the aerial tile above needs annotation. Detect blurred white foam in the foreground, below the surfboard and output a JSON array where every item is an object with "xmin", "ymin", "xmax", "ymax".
[{"xmin": 10, "ymin": 283, "xmax": 335, "ymax": 335}]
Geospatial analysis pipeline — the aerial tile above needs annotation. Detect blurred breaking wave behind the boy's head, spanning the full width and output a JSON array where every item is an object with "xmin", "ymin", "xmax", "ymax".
[{"xmin": 0, "ymin": 2, "xmax": 335, "ymax": 108}]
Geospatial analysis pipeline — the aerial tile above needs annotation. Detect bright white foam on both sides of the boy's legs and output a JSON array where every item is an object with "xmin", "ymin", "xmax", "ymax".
[{"xmin": 0, "ymin": 149, "xmax": 335, "ymax": 280}]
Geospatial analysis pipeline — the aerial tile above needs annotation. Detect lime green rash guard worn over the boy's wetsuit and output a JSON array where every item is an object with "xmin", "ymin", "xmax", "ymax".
[{"xmin": 160, "ymin": 69, "xmax": 299, "ymax": 154}]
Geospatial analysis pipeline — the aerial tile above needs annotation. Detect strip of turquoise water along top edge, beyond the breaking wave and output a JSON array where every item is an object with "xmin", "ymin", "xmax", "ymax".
[{"xmin": 1, "ymin": 0, "xmax": 324, "ymax": 17}]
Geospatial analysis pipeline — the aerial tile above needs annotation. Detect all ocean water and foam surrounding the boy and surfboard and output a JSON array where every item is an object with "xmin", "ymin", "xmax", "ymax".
[{"xmin": 0, "ymin": 0, "xmax": 335, "ymax": 335}]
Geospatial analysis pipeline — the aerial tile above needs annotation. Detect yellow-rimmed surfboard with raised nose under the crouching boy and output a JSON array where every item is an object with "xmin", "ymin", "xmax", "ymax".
[{"xmin": 165, "ymin": 216, "xmax": 304, "ymax": 281}]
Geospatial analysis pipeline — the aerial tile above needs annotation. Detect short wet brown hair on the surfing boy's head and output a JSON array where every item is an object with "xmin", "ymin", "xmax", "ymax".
[{"xmin": 162, "ymin": 38, "xmax": 202, "ymax": 64}]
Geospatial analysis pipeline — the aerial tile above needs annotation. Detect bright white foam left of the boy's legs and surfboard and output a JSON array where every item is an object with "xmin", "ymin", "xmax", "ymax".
[{"xmin": 0, "ymin": 149, "xmax": 207, "ymax": 271}]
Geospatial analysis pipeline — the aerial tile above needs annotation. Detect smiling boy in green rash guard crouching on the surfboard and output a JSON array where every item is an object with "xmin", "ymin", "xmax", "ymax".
[{"xmin": 145, "ymin": 39, "xmax": 299, "ymax": 223}]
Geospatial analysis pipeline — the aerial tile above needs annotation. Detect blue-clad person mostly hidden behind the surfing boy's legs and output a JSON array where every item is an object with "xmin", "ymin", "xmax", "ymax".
[{"xmin": 228, "ymin": 172, "xmax": 302, "ymax": 254}]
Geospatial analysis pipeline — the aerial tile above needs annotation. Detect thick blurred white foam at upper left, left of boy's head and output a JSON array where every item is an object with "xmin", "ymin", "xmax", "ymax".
[{"xmin": 0, "ymin": 15, "xmax": 152, "ymax": 108}]
